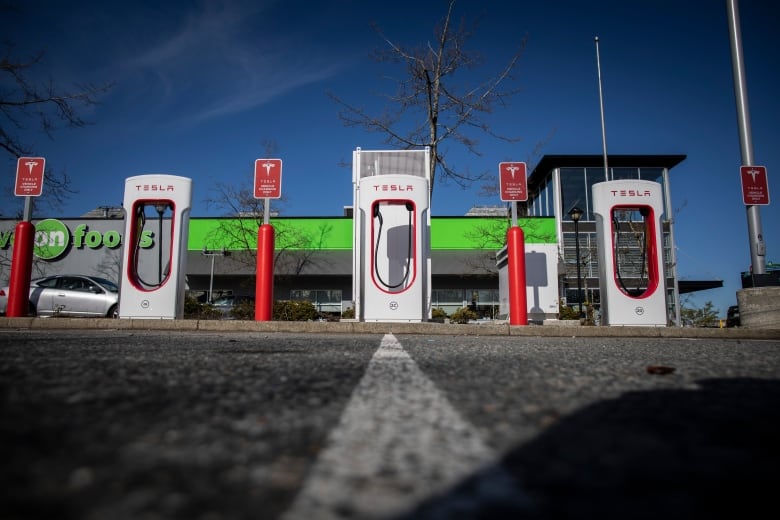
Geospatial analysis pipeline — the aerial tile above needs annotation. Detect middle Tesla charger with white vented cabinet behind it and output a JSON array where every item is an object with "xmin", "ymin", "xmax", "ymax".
[{"xmin": 352, "ymin": 148, "xmax": 431, "ymax": 322}]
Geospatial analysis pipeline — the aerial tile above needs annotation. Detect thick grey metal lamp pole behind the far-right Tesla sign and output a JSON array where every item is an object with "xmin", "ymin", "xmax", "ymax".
[{"xmin": 726, "ymin": 0, "xmax": 766, "ymax": 274}]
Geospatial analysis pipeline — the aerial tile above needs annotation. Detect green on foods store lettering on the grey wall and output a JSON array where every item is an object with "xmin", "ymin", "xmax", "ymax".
[{"xmin": 0, "ymin": 218, "xmax": 154, "ymax": 260}]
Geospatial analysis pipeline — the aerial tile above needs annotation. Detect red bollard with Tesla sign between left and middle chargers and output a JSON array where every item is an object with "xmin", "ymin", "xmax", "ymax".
[{"xmin": 254, "ymin": 159, "xmax": 282, "ymax": 321}]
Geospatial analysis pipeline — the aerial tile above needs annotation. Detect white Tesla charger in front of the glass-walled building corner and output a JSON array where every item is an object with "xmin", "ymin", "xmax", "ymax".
[{"xmin": 593, "ymin": 180, "xmax": 667, "ymax": 326}]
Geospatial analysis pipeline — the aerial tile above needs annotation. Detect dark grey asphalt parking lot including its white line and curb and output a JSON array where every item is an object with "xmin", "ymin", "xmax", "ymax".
[{"xmin": 0, "ymin": 318, "xmax": 780, "ymax": 520}]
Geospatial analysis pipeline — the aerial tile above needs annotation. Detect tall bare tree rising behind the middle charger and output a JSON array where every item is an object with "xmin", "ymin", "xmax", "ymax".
[{"xmin": 329, "ymin": 0, "xmax": 525, "ymax": 195}]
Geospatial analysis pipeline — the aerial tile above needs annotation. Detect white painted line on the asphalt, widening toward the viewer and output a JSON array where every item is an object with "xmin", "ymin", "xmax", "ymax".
[{"xmin": 283, "ymin": 334, "xmax": 506, "ymax": 520}]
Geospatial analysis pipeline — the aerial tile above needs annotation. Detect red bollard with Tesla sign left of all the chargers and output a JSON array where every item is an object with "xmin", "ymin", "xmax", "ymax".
[{"xmin": 5, "ymin": 157, "xmax": 46, "ymax": 318}]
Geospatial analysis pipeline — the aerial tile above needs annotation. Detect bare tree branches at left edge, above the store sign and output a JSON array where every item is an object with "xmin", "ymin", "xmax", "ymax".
[{"xmin": 0, "ymin": 37, "xmax": 113, "ymax": 211}]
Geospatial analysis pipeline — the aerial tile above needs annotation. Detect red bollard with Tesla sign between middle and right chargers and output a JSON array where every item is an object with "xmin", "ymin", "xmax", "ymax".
[{"xmin": 498, "ymin": 162, "xmax": 528, "ymax": 325}]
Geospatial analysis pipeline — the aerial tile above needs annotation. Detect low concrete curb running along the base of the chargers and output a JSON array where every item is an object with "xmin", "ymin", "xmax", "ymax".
[{"xmin": 0, "ymin": 318, "xmax": 780, "ymax": 340}]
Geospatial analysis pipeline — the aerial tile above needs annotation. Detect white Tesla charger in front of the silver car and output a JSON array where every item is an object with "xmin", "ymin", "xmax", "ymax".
[{"xmin": 119, "ymin": 175, "xmax": 192, "ymax": 319}]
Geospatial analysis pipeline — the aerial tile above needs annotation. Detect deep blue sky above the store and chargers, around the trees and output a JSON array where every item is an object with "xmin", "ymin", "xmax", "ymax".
[{"xmin": 0, "ymin": 0, "xmax": 780, "ymax": 316}]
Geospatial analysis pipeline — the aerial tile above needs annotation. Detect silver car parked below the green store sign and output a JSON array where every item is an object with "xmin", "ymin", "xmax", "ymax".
[{"xmin": 0, "ymin": 274, "xmax": 119, "ymax": 318}]
